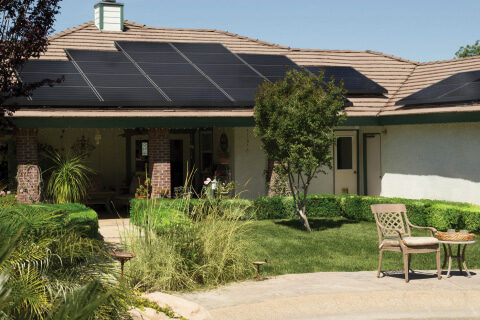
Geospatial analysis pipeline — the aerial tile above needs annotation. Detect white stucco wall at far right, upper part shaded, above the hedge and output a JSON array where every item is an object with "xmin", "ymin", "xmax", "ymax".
[{"xmin": 381, "ymin": 123, "xmax": 480, "ymax": 203}]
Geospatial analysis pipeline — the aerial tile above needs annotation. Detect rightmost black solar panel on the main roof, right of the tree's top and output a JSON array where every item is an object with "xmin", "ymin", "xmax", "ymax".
[{"xmin": 304, "ymin": 66, "xmax": 387, "ymax": 95}]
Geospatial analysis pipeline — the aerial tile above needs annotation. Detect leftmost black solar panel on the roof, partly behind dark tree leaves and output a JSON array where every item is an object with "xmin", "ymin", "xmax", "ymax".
[{"xmin": 18, "ymin": 60, "xmax": 99, "ymax": 101}]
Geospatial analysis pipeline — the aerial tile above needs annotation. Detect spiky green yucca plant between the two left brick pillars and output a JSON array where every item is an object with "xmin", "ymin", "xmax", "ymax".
[{"xmin": 46, "ymin": 151, "xmax": 94, "ymax": 203}]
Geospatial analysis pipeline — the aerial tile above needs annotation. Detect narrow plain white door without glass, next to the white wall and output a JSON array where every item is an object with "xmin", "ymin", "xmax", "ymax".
[{"xmin": 365, "ymin": 133, "xmax": 382, "ymax": 196}]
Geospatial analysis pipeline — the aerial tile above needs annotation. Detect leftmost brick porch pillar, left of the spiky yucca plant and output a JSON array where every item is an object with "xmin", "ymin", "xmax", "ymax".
[{"xmin": 16, "ymin": 128, "xmax": 41, "ymax": 203}]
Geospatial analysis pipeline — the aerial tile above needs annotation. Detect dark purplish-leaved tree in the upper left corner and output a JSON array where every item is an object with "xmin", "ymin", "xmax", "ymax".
[{"xmin": 0, "ymin": 0, "xmax": 61, "ymax": 124}]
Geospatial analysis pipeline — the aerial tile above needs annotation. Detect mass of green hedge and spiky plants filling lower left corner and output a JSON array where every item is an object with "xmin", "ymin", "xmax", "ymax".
[{"xmin": 0, "ymin": 205, "xmax": 127, "ymax": 319}]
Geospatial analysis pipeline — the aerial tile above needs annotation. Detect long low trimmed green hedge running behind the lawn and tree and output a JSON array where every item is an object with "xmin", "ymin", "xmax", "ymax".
[{"xmin": 130, "ymin": 194, "xmax": 480, "ymax": 232}]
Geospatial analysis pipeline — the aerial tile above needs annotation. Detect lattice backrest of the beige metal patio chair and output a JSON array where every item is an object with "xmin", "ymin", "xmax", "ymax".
[{"xmin": 370, "ymin": 204, "xmax": 410, "ymax": 242}]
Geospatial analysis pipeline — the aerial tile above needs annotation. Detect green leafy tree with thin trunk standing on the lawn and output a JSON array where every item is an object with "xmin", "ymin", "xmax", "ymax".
[{"xmin": 254, "ymin": 70, "xmax": 345, "ymax": 231}]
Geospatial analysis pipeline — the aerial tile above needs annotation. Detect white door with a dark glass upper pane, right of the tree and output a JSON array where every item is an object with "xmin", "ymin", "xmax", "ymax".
[{"xmin": 334, "ymin": 131, "xmax": 357, "ymax": 194}]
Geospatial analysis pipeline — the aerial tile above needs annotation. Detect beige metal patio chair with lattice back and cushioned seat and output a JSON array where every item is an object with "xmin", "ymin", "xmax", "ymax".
[{"xmin": 370, "ymin": 204, "xmax": 442, "ymax": 282}]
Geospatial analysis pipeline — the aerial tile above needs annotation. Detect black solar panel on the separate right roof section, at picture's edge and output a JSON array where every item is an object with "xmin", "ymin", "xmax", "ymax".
[{"xmin": 396, "ymin": 70, "xmax": 480, "ymax": 105}]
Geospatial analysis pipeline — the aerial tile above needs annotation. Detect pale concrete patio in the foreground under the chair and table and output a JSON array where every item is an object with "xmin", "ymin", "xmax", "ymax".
[{"xmin": 178, "ymin": 270, "xmax": 480, "ymax": 320}]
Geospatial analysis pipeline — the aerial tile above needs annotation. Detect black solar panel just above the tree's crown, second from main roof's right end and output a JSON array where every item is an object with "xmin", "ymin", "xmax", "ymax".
[{"xmin": 239, "ymin": 53, "xmax": 300, "ymax": 82}]
